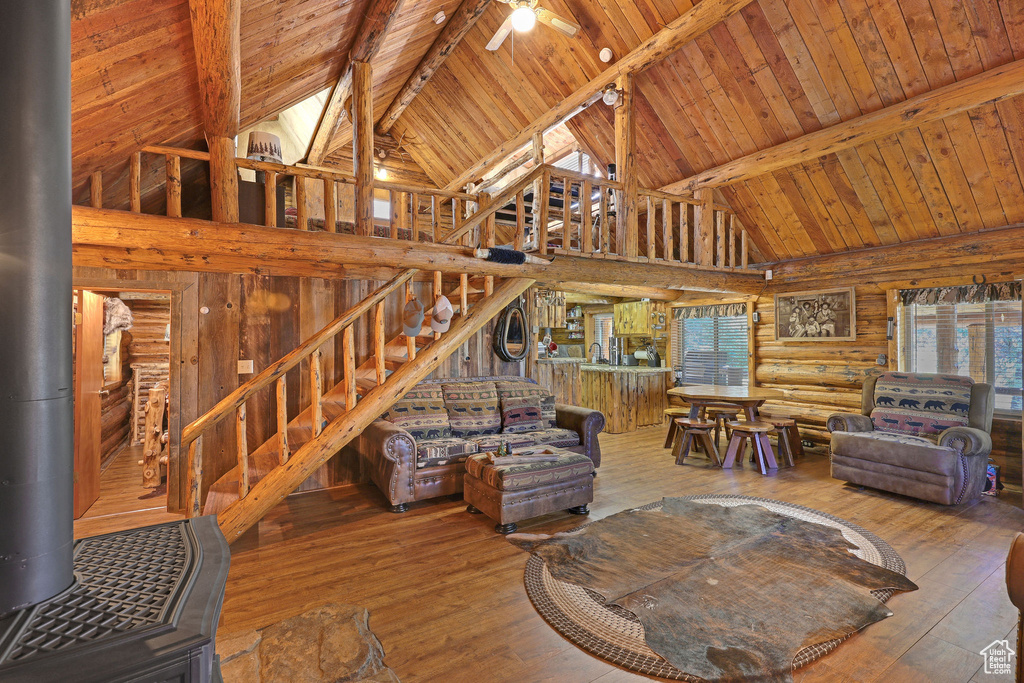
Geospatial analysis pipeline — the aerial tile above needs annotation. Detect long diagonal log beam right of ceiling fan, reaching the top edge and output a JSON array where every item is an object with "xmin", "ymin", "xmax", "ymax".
[{"xmin": 447, "ymin": 0, "xmax": 753, "ymax": 189}]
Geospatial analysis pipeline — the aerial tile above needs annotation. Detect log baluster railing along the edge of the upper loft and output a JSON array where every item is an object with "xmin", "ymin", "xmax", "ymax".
[{"xmin": 81, "ymin": 146, "xmax": 750, "ymax": 270}]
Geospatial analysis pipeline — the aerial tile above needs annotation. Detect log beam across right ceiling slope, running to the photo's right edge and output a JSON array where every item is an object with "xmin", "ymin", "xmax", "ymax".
[{"xmin": 662, "ymin": 59, "xmax": 1024, "ymax": 193}]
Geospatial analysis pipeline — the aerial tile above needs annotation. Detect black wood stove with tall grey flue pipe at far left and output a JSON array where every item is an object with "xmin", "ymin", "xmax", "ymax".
[{"xmin": 0, "ymin": 0, "xmax": 229, "ymax": 683}]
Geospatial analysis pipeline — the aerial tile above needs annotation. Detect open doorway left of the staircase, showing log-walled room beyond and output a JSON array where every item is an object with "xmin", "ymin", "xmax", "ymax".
[{"xmin": 73, "ymin": 288, "xmax": 172, "ymax": 519}]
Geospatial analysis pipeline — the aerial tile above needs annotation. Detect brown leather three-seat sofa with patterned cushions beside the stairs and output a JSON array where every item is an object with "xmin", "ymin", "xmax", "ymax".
[{"xmin": 356, "ymin": 377, "xmax": 604, "ymax": 512}]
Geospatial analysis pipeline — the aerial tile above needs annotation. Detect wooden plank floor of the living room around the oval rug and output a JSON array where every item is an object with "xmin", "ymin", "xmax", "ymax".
[{"xmin": 77, "ymin": 427, "xmax": 1024, "ymax": 683}]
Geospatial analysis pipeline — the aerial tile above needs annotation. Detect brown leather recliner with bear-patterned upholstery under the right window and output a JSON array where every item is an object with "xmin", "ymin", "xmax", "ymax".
[{"xmin": 827, "ymin": 373, "xmax": 995, "ymax": 505}]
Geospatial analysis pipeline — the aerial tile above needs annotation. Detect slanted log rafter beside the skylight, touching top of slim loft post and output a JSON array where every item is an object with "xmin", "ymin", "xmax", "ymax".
[{"xmin": 306, "ymin": 0, "xmax": 404, "ymax": 166}]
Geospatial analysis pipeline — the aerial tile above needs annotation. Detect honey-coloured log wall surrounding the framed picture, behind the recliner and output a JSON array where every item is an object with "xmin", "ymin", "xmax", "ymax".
[{"xmin": 755, "ymin": 237, "xmax": 1021, "ymax": 489}]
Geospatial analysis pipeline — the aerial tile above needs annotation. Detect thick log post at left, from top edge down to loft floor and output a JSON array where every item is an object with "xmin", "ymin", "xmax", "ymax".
[{"xmin": 188, "ymin": 0, "xmax": 242, "ymax": 222}]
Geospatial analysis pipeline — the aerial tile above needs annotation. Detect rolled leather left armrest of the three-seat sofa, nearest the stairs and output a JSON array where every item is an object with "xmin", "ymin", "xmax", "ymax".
[{"xmin": 358, "ymin": 420, "xmax": 416, "ymax": 506}]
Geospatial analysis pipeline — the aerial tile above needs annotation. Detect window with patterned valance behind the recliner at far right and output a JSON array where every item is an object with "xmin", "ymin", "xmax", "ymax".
[{"xmin": 898, "ymin": 301, "xmax": 1022, "ymax": 415}]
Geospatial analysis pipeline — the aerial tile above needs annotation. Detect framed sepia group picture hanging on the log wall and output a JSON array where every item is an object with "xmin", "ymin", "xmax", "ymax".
[{"xmin": 775, "ymin": 287, "xmax": 857, "ymax": 341}]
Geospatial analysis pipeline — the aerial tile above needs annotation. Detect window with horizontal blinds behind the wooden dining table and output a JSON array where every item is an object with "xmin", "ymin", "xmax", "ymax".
[{"xmin": 672, "ymin": 311, "xmax": 750, "ymax": 386}]
